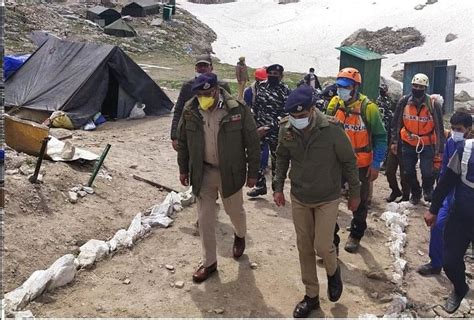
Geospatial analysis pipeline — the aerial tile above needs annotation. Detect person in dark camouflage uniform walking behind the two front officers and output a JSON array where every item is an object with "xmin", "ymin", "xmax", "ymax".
[{"xmin": 247, "ymin": 64, "xmax": 290, "ymax": 197}]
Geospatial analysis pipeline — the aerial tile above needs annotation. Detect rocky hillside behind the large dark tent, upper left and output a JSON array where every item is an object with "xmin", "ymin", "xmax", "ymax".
[{"xmin": 5, "ymin": 1, "xmax": 216, "ymax": 56}]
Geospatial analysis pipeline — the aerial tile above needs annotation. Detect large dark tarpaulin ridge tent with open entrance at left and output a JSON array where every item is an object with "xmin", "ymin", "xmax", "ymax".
[{"xmin": 5, "ymin": 38, "xmax": 173, "ymax": 128}]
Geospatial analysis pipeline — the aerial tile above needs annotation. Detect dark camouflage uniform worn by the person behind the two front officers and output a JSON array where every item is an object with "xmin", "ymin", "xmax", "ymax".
[{"xmin": 252, "ymin": 81, "xmax": 290, "ymax": 188}]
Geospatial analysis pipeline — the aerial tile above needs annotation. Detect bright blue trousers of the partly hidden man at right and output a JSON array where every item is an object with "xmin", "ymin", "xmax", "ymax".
[{"xmin": 429, "ymin": 198, "xmax": 453, "ymax": 268}]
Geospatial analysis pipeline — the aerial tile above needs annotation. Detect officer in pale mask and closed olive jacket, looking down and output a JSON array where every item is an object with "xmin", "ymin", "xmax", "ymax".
[{"xmin": 273, "ymin": 85, "xmax": 360, "ymax": 318}]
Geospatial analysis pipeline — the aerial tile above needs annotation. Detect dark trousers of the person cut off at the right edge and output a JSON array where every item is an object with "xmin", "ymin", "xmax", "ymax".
[{"xmin": 443, "ymin": 211, "xmax": 474, "ymax": 296}]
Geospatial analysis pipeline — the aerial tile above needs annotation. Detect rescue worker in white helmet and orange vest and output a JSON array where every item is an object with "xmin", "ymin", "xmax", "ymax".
[{"xmin": 390, "ymin": 73, "xmax": 446, "ymax": 204}]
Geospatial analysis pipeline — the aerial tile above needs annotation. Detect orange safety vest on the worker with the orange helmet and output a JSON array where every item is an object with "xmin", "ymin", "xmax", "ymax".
[{"xmin": 334, "ymin": 98, "xmax": 372, "ymax": 168}]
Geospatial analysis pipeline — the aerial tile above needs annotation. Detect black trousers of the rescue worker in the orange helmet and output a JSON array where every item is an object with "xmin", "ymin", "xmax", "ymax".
[{"xmin": 334, "ymin": 167, "xmax": 370, "ymax": 241}]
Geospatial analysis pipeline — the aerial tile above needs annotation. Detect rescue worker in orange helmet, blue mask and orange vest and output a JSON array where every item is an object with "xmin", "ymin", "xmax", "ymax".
[{"xmin": 326, "ymin": 68, "xmax": 387, "ymax": 253}]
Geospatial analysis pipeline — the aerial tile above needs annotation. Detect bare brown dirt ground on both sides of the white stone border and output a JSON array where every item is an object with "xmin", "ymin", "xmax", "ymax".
[{"xmin": 4, "ymin": 92, "xmax": 474, "ymax": 317}]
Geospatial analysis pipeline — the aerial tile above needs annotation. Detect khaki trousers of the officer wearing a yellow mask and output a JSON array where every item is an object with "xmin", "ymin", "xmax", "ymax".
[{"xmin": 197, "ymin": 166, "xmax": 247, "ymax": 267}]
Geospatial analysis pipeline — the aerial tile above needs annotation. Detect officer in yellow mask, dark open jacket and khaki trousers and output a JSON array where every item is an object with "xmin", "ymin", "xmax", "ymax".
[{"xmin": 178, "ymin": 73, "xmax": 260, "ymax": 282}]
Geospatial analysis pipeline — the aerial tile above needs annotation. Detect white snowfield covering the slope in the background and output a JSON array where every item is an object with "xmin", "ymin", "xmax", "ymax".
[{"xmin": 177, "ymin": 0, "xmax": 474, "ymax": 96}]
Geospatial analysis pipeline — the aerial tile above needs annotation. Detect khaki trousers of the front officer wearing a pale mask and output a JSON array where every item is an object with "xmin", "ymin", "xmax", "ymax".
[{"xmin": 291, "ymin": 195, "xmax": 339, "ymax": 298}]
